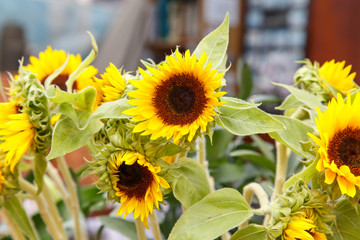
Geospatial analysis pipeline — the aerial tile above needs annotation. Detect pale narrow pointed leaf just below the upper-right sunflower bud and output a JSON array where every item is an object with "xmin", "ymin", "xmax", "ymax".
[{"xmin": 275, "ymin": 83, "xmax": 325, "ymax": 111}]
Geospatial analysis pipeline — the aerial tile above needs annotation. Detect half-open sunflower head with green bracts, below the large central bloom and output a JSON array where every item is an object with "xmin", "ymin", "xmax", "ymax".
[{"xmin": 88, "ymin": 120, "xmax": 170, "ymax": 226}]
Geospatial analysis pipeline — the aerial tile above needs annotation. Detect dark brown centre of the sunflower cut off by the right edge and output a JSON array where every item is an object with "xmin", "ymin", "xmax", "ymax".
[{"xmin": 327, "ymin": 127, "xmax": 360, "ymax": 176}]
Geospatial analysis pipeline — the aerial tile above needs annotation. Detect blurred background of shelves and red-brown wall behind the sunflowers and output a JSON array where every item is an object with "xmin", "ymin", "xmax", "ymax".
[{"xmin": 0, "ymin": 0, "xmax": 360, "ymax": 239}]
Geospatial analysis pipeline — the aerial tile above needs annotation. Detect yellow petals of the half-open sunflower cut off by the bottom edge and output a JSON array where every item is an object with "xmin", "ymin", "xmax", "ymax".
[{"xmin": 282, "ymin": 208, "xmax": 327, "ymax": 240}]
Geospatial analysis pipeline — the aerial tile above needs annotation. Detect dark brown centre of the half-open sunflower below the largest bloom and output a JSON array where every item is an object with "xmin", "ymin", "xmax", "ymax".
[{"xmin": 117, "ymin": 162, "xmax": 154, "ymax": 200}]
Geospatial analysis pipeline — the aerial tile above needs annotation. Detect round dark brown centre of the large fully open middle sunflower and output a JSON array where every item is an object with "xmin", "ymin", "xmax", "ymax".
[{"xmin": 153, "ymin": 73, "xmax": 207, "ymax": 126}]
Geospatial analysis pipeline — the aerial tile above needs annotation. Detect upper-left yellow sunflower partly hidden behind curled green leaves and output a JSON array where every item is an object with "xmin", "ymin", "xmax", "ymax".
[{"xmin": 24, "ymin": 46, "xmax": 97, "ymax": 91}]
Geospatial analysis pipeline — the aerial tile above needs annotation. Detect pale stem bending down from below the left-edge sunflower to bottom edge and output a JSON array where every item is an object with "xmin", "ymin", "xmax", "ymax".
[{"xmin": 19, "ymin": 177, "xmax": 67, "ymax": 240}]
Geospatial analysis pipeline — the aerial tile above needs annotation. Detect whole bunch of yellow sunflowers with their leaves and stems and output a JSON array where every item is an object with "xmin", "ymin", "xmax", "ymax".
[{"xmin": 0, "ymin": 13, "xmax": 360, "ymax": 240}]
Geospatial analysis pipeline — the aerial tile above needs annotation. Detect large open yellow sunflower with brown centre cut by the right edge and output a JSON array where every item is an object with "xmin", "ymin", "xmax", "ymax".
[{"xmin": 309, "ymin": 93, "xmax": 360, "ymax": 197}]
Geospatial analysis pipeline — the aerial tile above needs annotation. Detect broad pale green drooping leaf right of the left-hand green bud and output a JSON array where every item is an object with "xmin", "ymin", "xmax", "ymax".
[{"xmin": 46, "ymin": 114, "xmax": 103, "ymax": 159}]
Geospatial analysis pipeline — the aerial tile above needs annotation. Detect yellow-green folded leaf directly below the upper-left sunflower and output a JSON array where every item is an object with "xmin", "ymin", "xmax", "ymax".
[{"xmin": 46, "ymin": 85, "xmax": 96, "ymax": 112}]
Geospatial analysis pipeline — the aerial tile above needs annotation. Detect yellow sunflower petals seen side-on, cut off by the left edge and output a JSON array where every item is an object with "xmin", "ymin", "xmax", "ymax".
[{"xmin": 0, "ymin": 100, "xmax": 35, "ymax": 172}]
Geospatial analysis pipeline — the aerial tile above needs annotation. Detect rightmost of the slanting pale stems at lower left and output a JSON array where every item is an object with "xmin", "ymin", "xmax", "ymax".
[{"xmin": 57, "ymin": 157, "xmax": 86, "ymax": 240}]
